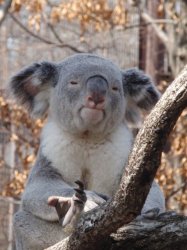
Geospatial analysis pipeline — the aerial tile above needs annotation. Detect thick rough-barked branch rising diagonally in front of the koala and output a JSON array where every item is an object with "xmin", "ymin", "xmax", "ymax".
[{"xmin": 45, "ymin": 66, "xmax": 187, "ymax": 250}]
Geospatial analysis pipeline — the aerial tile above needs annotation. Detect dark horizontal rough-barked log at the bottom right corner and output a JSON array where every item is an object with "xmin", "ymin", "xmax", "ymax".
[{"xmin": 110, "ymin": 213, "xmax": 187, "ymax": 250}]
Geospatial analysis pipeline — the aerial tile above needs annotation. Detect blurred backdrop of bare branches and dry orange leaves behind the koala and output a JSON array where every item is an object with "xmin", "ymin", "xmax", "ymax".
[{"xmin": 0, "ymin": 0, "xmax": 187, "ymax": 250}]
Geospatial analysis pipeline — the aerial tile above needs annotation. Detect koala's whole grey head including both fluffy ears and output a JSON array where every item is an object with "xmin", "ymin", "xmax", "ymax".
[{"xmin": 11, "ymin": 54, "xmax": 159, "ymax": 137}]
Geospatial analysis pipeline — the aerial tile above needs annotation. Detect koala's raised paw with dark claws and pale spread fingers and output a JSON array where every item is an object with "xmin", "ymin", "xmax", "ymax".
[{"xmin": 48, "ymin": 181, "xmax": 87, "ymax": 227}]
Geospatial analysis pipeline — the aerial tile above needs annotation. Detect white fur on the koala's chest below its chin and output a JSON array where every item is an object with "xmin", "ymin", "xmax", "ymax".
[{"xmin": 42, "ymin": 122, "xmax": 132, "ymax": 195}]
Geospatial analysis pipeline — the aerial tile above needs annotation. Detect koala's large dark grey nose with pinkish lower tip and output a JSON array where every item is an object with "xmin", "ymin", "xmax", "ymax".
[{"xmin": 86, "ymin": 76, "xmax": 108, "ymax": 106}]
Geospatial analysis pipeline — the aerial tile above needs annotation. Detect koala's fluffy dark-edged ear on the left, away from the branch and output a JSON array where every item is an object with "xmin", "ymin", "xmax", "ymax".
[{"xmin": 10, "ymin": 62, "xmax": 58, "ymax": 116}]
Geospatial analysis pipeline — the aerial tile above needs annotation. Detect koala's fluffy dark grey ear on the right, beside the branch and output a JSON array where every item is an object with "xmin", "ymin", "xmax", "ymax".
[{"xmin": 122, "ymin": 68, "xmax": 160, "ymax": 123}]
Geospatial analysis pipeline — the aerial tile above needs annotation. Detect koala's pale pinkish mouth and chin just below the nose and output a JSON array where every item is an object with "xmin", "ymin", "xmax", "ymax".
[{"xmin": 80, "ymin": 106, "xmax": 105, "ymax": 125}]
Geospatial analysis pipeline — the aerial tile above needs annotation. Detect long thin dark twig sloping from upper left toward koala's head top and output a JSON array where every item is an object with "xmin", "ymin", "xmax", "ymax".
[{"xmin": 9, "ymin": 13, "xmax": 85, "ymax": 53}]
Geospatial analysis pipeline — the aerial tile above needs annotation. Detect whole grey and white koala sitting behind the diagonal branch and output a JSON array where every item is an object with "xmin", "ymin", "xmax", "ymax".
[{"xmin": 10, "ymin": 54, "xmax": 165, "ymax": 250}]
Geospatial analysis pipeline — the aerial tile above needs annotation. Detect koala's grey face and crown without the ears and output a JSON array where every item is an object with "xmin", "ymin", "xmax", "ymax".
[{"xmin": 50, "ymin": 55, "xmax": 125, "ymax": 133}]
